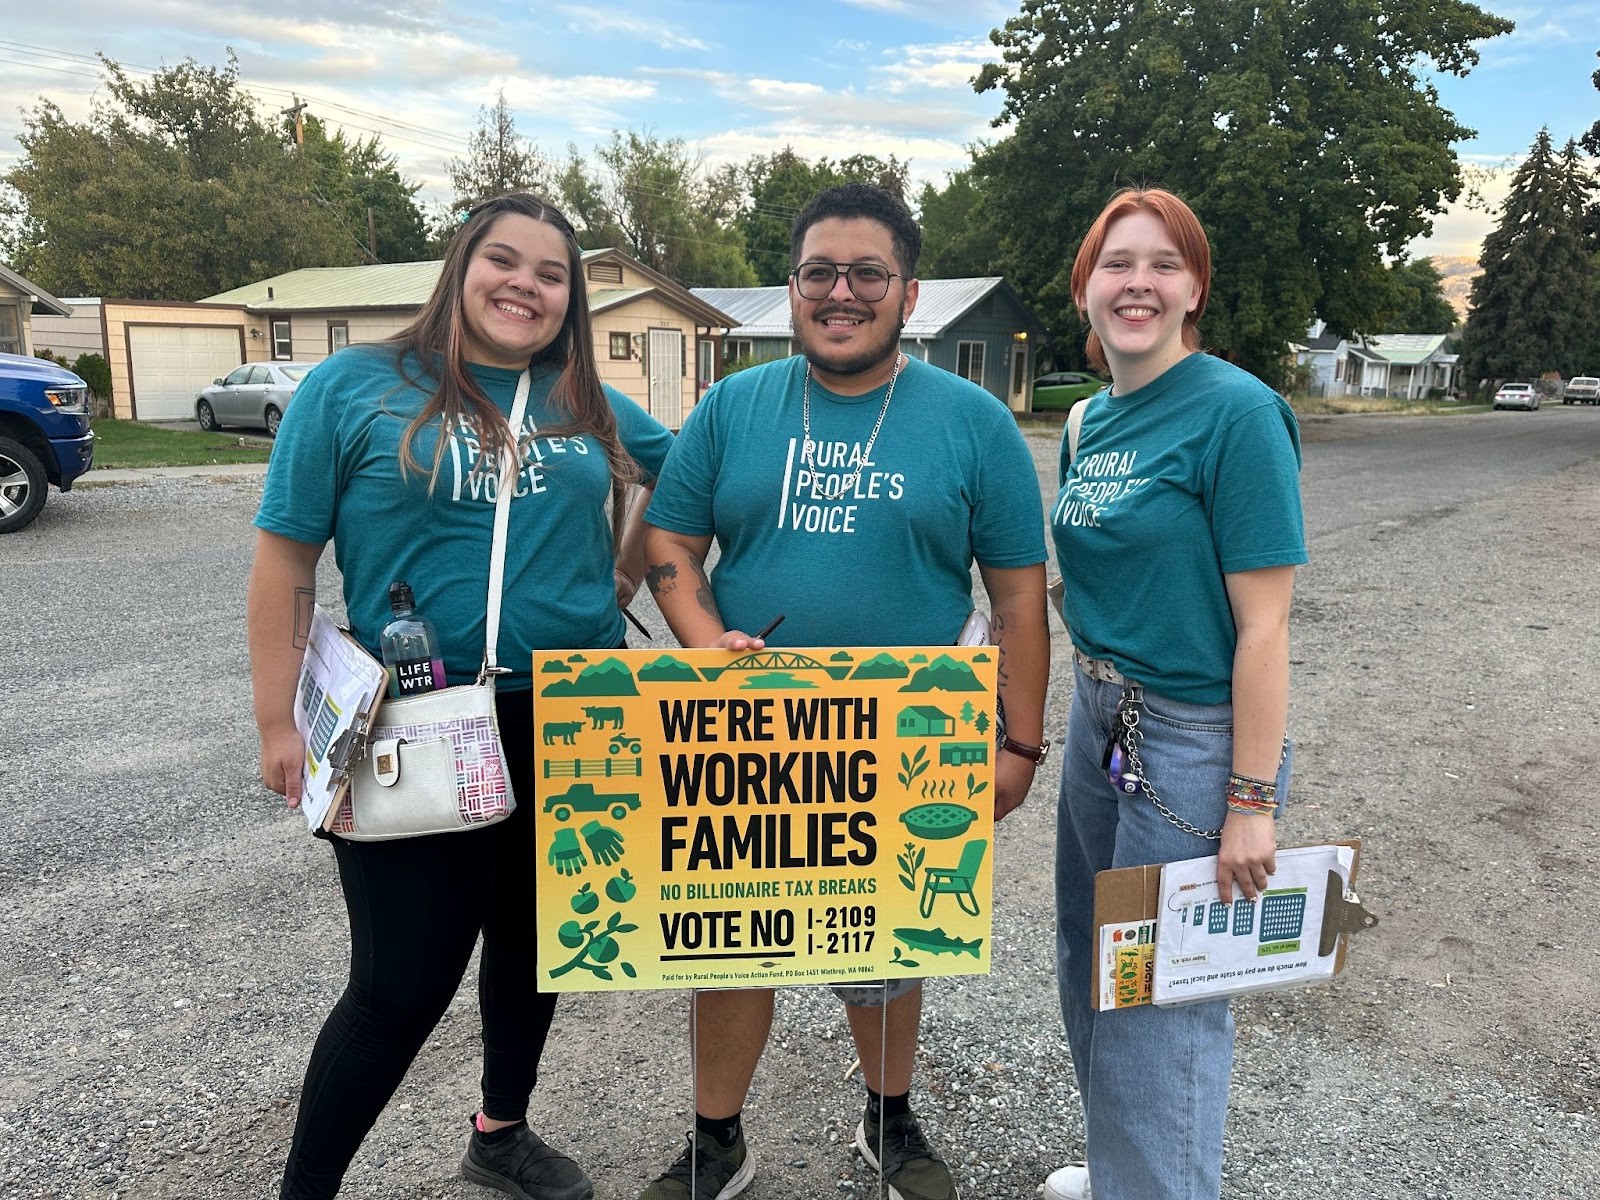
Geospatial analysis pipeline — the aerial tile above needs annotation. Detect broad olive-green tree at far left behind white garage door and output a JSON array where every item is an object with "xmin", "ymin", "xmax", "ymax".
[{"xmin": 5, "ymin": 53, "xmax": 362, "ymax": 301}]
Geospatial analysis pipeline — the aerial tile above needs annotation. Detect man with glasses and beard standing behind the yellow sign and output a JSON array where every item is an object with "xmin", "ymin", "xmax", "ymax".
[{"xmin": 640, "ymin": 184, "xmax": 1050, "ymax": 1200}]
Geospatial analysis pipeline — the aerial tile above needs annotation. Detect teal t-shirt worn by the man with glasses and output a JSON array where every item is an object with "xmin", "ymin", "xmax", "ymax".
[{"xmin": 648, "ymin": 357, "xmax": 1045, "ymax": 646}]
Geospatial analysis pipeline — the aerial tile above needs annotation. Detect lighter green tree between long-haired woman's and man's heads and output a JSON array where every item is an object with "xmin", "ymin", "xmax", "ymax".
[{"xmin": 588, "ymin": 130, "xmax": 755, "ymax": 288}]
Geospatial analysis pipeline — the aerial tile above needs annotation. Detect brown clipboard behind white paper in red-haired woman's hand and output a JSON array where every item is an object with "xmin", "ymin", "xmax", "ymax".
[{"xmin": 1090, "ymin": 838, "xmax": 1378, "ymax": 1011}]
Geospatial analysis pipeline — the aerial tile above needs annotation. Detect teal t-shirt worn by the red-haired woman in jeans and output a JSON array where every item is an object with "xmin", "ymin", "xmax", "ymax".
[{"xmin": 1050, "ymin": 354, "xmax": 1306, "ymax": 704}]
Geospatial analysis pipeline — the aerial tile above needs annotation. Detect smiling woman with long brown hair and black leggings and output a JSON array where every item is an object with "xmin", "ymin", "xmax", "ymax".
[{"xmin": 250, "ymin": 194, "xmax": 672, "ymax": 1200}]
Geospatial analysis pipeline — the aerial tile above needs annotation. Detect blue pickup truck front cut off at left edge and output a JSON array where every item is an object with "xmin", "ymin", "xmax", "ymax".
[{"xmin": 0, "ymin": 354, "xmax": 94, "ymax": 533}]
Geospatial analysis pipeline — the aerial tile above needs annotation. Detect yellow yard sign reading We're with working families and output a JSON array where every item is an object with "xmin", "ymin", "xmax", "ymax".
[{"xmin": 531, "ymin": 646, "xmax": 995, "ymax": 992}]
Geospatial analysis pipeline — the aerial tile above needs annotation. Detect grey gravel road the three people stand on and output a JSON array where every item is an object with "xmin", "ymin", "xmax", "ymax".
[{"xmin": 0, "ymin": 410, "xmax": 1600, "ymax": 1200}]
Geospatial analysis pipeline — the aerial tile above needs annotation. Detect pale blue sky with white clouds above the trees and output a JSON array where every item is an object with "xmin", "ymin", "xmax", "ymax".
[{"xmin": 0, "ymin": 0, "xmax": 1600, "ymax": 262}]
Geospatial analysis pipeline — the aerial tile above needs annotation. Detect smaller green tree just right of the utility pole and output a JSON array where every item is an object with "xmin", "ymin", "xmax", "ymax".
[{"xmin": 297, "ymin": 114, "xmax": 429, "ymax": 262}]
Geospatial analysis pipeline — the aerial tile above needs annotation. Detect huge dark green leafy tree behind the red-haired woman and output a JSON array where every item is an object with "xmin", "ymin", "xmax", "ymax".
[{"xmin": 974, "ymin": 0, "xmax": 1512, "ymax": 382}]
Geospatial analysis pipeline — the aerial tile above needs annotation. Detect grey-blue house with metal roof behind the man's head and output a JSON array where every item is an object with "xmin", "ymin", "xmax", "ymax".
[{"xmin": 694, "ymin": 275, "xmax": 1043, "ymax": 413}]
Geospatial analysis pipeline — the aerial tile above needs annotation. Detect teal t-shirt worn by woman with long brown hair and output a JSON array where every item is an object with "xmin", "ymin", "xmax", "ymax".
[{"xmin": 256, "ymin": 346, "xmax": 672, "ymax": 691}]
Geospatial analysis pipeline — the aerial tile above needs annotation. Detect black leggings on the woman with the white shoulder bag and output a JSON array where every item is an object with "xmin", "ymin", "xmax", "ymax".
[{"xmin": 282, "ymin": 691, "xmax": 557, "ymax": 1200}]
